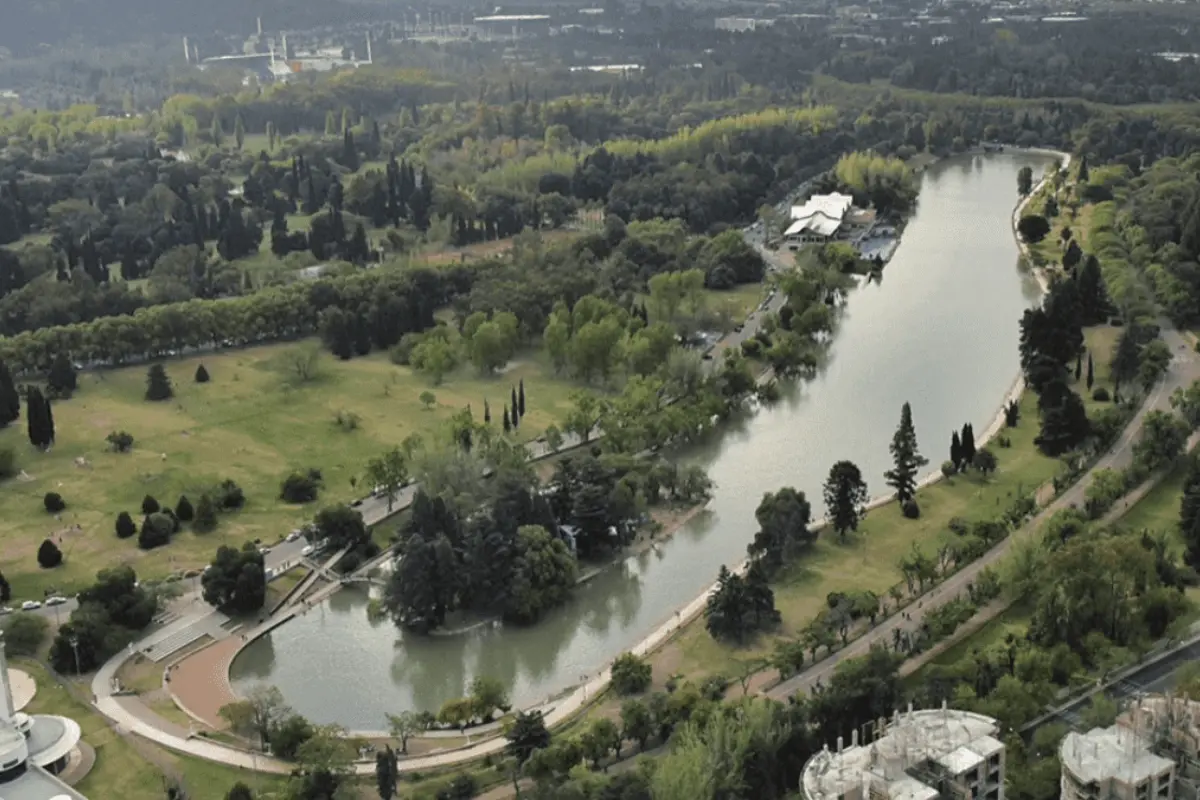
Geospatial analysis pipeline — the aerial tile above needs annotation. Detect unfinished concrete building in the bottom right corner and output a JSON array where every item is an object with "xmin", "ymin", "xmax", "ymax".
[{"xmin": 1058, "ymin": 694, "xmax": 1200, "ymax": 800}]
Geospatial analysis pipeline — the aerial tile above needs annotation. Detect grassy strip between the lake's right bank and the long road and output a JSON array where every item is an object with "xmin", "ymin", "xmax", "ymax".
[{"xmin": 661, "ymin": 393, "xmax": 1061, "ymax": 676}]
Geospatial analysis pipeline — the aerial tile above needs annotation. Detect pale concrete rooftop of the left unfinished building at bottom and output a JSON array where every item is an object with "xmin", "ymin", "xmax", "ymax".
[{"xmin": 803, "ymin": 706, "xmax": 1003, "ymax": 800}]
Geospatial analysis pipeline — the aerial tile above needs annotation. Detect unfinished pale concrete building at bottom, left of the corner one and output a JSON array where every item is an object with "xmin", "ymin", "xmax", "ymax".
[{"xmin": 800, "ymin": 704, "xmax": 1004, "ymax": 800}]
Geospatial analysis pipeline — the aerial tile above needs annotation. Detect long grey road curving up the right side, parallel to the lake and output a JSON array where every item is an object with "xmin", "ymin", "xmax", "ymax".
[{"xmin": 768, "ymin": 320, "xmax": 1200, "ymax": 699}]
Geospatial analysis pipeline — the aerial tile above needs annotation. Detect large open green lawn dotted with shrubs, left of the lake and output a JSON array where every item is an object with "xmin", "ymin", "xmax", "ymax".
[{"xmin": 0, "ymin": 344, "xmax": 575, "ymax": 600}]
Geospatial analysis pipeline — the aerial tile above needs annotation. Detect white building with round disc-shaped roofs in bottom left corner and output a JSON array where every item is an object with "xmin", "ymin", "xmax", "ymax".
[{"xmin": 0, "ymin": 637, "xmax": 86, "ymax": 800}]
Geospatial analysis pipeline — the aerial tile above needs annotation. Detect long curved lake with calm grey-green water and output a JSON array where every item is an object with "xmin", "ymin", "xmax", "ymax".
[{"xmin": 232, "ymin": 152, "xmax": 1055, "ymax": 730}]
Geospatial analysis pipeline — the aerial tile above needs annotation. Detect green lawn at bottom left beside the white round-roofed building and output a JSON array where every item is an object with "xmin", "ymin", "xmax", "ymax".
[{"xmin": 18, "ymin": 661, "xmax": 283, "ymax": 800}]
